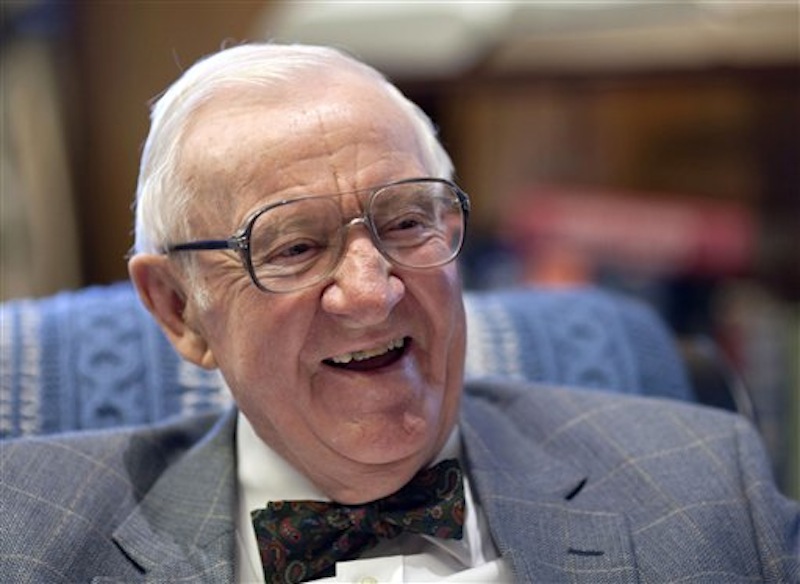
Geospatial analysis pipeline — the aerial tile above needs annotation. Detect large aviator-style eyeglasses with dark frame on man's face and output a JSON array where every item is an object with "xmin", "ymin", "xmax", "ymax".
[{"xmin": 165, "ymin": 178, "xmax": 470, "ymax": 293}]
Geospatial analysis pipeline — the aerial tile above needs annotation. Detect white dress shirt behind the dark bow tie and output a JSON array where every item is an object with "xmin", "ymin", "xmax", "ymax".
[{"xmin": 236, "ymin": 413, "xmax": 513, "ymax": 584}]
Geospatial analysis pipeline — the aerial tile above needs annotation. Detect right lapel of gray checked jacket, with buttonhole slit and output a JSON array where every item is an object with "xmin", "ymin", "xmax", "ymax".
[{"xmin": 462, "ymin": 380, "xmax": 638, "ymax": 584}]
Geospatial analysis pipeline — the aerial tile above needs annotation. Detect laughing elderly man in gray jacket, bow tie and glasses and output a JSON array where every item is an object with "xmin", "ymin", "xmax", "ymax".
[{"xmin": 0, "ymin": 45, "xmax": 800, "ymax": 582}]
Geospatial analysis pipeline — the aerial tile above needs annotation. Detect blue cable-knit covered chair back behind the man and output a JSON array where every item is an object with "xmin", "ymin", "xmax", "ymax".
[{"xmin": 0, "ymin": 282, "xmax": 694, "ymax": 438}]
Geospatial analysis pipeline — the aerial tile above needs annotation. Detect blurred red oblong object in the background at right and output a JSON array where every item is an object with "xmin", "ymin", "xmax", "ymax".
[{"xmin": 502, "ymin": 187, "xmax": 756, "ymax": 277}]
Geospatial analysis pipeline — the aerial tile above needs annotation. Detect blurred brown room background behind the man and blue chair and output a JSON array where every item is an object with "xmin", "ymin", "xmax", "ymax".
[{"xmin": 0, "ymin": 0, "xmax": 800, "ymax": 496}]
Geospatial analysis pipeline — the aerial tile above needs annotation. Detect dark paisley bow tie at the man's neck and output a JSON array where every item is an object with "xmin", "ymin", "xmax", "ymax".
[{"xmin": 251, "ymin": 460, "xmax": 464, "ymax": 583}]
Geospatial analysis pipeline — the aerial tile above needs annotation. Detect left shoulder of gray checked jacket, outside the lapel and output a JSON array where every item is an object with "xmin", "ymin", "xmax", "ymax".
[{"xmin": 0, "ymin": 414, "xmax": 225, "ymax": 582}]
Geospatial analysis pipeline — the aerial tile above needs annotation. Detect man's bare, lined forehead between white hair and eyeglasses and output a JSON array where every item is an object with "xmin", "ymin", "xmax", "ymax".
[{"xmin": 179, "ymin": 73, "xmax": 425, "ymax": 210}]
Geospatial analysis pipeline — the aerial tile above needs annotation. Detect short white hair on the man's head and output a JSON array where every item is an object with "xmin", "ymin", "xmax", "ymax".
[{"xmin": 134, "ymin": 43, "xmax": 453, "ymax": 253}]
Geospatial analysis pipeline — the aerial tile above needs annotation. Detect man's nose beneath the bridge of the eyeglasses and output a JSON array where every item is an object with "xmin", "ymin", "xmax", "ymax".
[{"xmin": 322, "ymin": 232, "xmax": 405, "ymax": 327}]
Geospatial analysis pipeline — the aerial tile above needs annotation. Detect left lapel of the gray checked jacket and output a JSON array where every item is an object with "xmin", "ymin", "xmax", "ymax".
[{"xmin": 107, "ymin": 411, "xmax": 236, "ymax": 583}]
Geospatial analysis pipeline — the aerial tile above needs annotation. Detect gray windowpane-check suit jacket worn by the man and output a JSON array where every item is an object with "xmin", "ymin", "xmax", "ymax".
[{"xmin": 0, "ymin": 382, "xmax": 800, "ymax": 584}]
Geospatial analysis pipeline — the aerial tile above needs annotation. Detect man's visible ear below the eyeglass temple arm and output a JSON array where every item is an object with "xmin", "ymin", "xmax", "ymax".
[{"xmin": 128, "ymin": 254, "xmax": 217, "ymax": 369}]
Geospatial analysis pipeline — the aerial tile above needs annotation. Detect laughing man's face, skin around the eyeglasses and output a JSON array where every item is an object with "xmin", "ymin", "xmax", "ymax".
[{"xmin": 172, "ymin": 75, "xmax": 465, "ymax": 503}]
